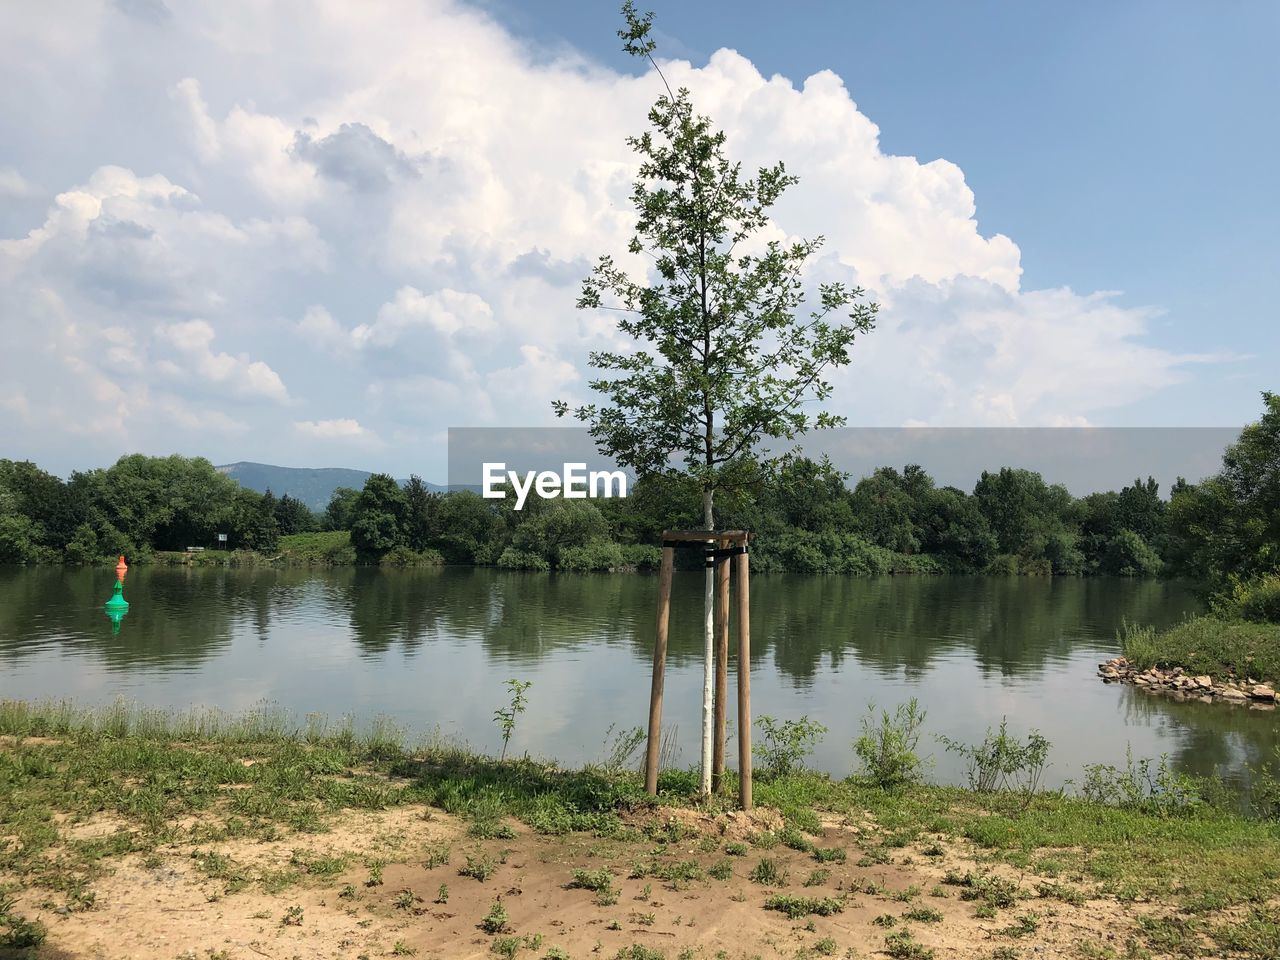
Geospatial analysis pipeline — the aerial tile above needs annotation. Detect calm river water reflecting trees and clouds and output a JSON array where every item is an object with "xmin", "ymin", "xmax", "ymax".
[{"xmin": 0, "ymin": 567, "xmax": 1277, "ymax": 783}]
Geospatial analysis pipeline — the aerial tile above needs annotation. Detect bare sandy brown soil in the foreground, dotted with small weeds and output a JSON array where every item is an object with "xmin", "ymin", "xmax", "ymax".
[{"xmin": 0, "ymin": 808, "xmax": 1134, "ymax": 960}]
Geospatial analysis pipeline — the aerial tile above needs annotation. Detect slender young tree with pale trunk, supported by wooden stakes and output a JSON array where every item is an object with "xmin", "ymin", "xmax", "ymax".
[{"xmin": 556, "ymin": 0, "xmax": 876, "ymax": 792}]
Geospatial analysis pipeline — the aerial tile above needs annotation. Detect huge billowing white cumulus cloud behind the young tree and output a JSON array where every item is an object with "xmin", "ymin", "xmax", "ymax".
[{"xmin": 0, "ymin": 0, "xmax": 1213, "ymax": 472}]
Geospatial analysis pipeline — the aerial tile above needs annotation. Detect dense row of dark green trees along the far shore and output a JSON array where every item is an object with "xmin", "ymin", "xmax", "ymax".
[{"xmin": 0, "ymin": 393, "xmax": 1280, "ymax": 589}]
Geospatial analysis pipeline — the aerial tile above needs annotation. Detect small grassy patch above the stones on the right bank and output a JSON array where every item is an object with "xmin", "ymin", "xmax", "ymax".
[{"xmin": 1120, "ymin": 616, "xmax": 1280, "ymax": 681}]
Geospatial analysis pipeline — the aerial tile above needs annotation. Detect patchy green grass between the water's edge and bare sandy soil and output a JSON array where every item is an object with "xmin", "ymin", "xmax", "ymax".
[{"xmin": 0, "ymin": 701, "xmax": 1280, "ymax": 957}]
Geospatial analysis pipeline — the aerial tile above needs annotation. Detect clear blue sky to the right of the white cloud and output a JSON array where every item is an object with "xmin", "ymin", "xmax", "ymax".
[{"xmin": 481, "ymin": 0, "xmax": 1280, "ymax": 425}]
